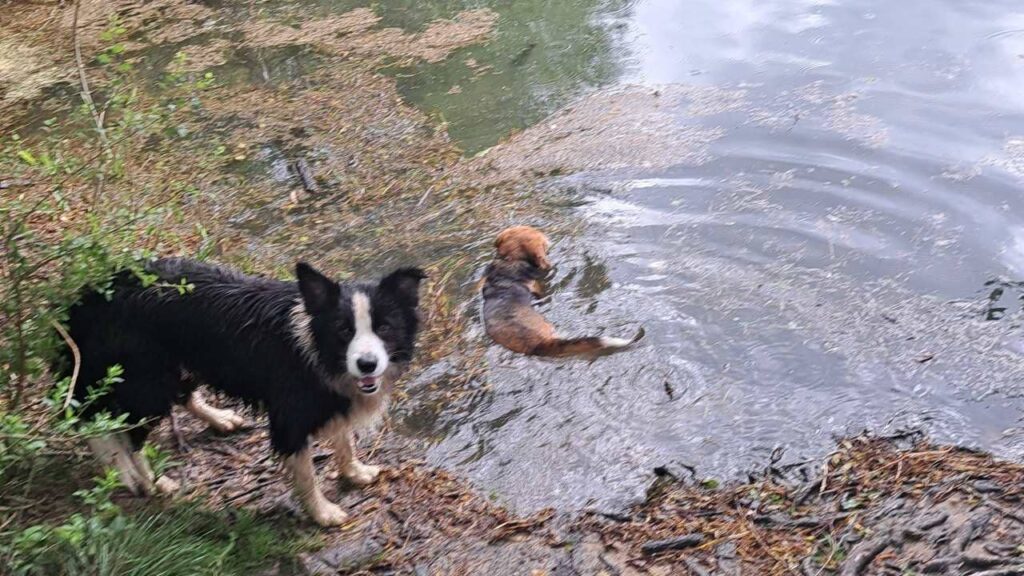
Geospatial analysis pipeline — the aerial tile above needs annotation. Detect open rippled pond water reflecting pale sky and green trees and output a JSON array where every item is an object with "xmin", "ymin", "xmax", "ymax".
[{"xmin": 378, "ymin": 0, "xmax": 1024, "ymax": 509}]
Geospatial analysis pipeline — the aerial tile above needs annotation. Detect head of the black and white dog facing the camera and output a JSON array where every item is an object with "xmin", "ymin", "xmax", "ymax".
[{"xmin": 293, "ymin": 262, "xmax": 426, "ymax": 395}]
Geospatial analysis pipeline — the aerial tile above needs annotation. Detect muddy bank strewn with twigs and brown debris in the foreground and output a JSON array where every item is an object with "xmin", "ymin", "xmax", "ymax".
[{"xmin": 226, "ymin": 422, "xmax": 1024, "ymax": 576}]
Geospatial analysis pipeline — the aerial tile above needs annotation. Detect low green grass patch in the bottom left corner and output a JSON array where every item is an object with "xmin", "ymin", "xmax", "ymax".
[{"xmin": 0, "ymin": 503, "xmax": 311, "ymax": 576}]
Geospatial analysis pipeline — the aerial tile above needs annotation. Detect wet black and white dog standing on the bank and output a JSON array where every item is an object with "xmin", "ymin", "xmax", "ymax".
[{"xmin": 60, "ymin": 258, "xmax": 425, "ymax": 526}]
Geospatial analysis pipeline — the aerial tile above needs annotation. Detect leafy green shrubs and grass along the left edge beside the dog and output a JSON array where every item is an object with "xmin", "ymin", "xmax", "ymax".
[{"xmin": 0, "ymin": 15, "xmax": 307, "ymax": 576}]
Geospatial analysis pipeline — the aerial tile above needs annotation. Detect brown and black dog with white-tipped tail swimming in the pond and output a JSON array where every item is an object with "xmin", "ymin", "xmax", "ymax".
[{"xmin": 482, "ymin": 225, "xmax": 643, "ymax": 357}]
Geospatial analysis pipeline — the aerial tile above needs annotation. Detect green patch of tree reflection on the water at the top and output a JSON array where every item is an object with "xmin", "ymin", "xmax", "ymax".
[{"xmin": 381, "ymin": 0, "xmax": 630, "ymax": 154}]
